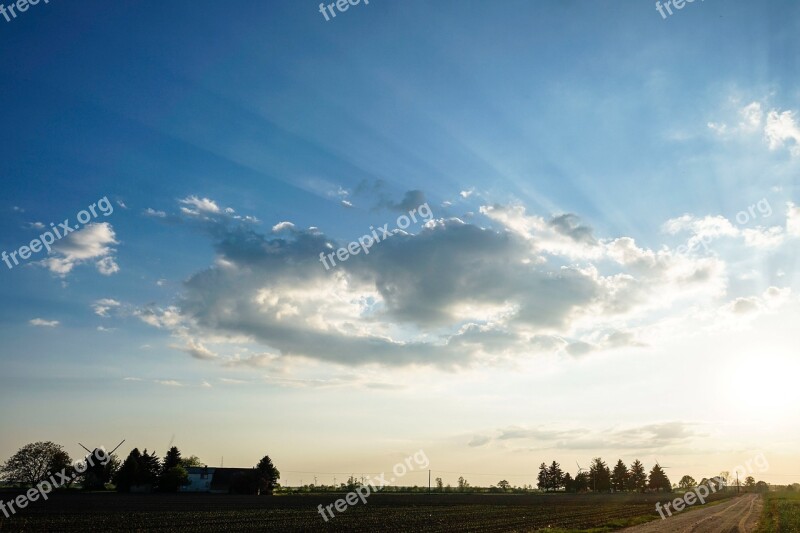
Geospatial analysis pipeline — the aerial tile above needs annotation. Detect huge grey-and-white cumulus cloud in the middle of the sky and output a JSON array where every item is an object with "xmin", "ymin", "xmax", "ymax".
[{"xmin": 128, "ymin": 195, "xmax": 752, "ymax": 370}]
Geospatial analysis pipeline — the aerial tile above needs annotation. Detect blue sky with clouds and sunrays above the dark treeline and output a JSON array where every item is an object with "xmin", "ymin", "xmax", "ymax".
[{"xmin": 0, "ymin": 0, "xmax": 800, "ymax": 485}]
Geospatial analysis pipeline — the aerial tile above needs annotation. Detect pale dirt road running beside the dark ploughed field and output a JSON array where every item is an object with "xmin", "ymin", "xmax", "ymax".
[{"xmin": 623, "ymin": 494, "xmax": 762, "ymax": 533}]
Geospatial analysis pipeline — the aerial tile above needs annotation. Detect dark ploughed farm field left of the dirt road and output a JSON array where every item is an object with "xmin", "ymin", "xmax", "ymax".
[{"xmin": 0, "ymin": 493, "xmax": 736, "ymax": 532}]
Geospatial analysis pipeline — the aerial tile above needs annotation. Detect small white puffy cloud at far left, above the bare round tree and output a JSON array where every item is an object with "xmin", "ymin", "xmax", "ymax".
[{"xmin": 41, "ymin": 222, "xmax": 119, "ymax": 276}]
